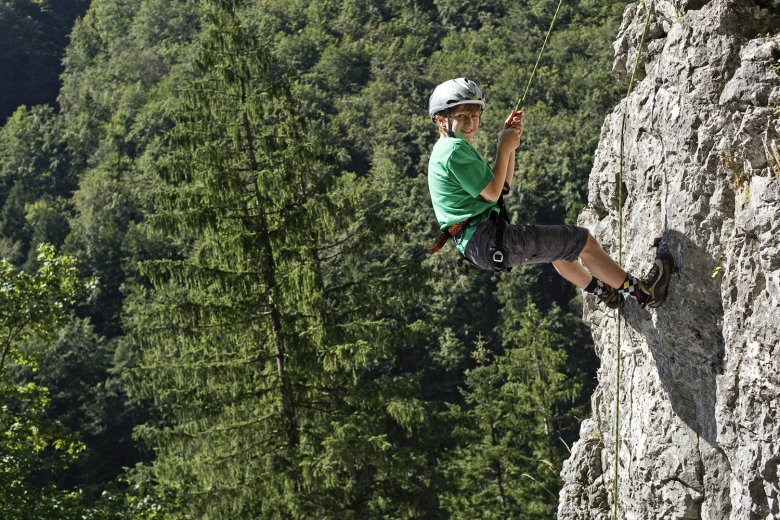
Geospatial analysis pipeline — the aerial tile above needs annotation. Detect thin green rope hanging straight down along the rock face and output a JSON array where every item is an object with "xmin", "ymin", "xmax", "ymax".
[{"xmin": 612, "ymin": 3, "xmax": 654, "ymax": 520}]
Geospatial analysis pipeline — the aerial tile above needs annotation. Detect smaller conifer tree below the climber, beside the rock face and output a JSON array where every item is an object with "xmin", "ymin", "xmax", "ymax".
[{"xmin": 443, "ymin": 301, "xmax": 581, "ymax": 519}]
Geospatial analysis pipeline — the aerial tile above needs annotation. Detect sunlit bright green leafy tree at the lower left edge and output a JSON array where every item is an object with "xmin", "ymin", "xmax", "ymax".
[{"xmin": 0, "ymin": 244, "xmax": 95, "ymax": 518}]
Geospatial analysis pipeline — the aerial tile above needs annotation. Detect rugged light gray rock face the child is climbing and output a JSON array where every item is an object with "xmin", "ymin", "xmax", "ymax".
[{"xmin": 558, "ymin": 0, "xmax": 780, "ymax": 520}]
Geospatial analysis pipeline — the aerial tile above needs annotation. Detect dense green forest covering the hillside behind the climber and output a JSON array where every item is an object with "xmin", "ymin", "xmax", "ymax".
[{"xmin": 0, "ymin": 0, "xmax": 626, "ymax": 519}]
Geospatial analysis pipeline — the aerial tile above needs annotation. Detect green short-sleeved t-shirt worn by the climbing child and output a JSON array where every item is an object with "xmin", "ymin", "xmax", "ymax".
[{"xmin": 428, "ymin": 137, "xmax": 498, "ymax": 253}]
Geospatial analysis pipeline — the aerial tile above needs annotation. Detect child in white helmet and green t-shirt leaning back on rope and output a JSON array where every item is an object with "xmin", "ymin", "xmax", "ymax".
[{"xmin": 428, "ymin": 78, "xmax": 674, "ymax": 308}]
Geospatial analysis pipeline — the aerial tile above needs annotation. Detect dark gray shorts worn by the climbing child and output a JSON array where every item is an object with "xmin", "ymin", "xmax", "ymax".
[{"xmin": 466, "ymin": 219, "xmax": 588, "ymax": 270}]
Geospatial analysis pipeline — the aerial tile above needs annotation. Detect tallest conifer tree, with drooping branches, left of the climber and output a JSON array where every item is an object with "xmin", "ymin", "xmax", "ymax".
[{"xmin": 128, "ymin": 0, "xmax": 427, "ymax": 518}]
